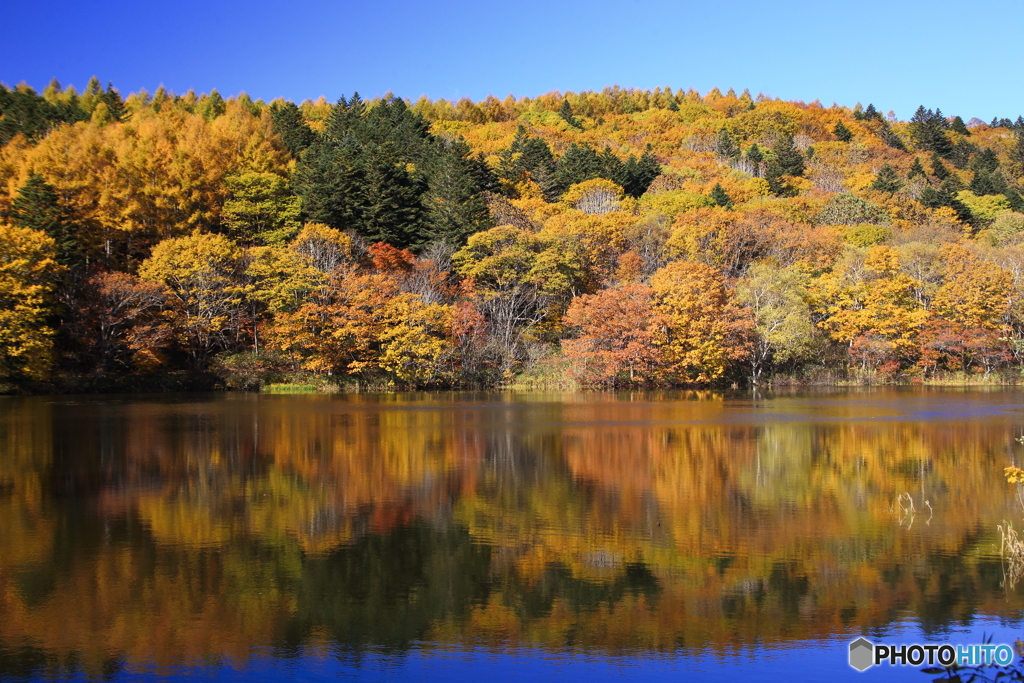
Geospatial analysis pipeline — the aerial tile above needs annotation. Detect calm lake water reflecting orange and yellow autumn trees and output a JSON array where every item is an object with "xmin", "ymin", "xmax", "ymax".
[{"xmin": 0, "ymin": 390, "xmax": 1024, "ymax": 682}]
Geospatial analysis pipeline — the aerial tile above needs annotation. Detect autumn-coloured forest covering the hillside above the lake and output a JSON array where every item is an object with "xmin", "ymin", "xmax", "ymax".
[{"xmin": 0, "ymin": 79, "xmax": 1024, "ymax": 391}]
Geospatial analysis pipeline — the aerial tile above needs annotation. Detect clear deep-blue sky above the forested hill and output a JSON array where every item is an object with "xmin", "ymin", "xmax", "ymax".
[{"xmin": 0, "ymin": 0, "xmax": 1024, "ymax": 121}]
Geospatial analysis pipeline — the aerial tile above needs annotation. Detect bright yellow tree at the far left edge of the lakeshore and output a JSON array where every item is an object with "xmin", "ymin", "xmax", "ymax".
[{"xmin": 0, "ymin": 223, "xmax": 60, "ymax": 382}]
